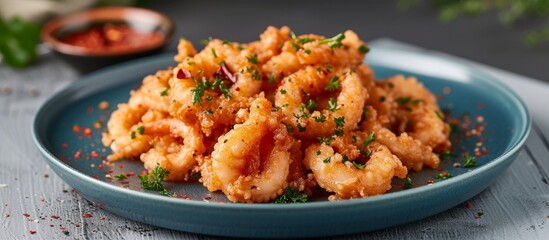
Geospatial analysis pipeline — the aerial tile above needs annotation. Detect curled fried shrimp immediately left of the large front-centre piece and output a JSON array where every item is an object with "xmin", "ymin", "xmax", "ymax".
[{"xmin": 141, "ymin": 118, "xmax": 206, "ymax": 181}]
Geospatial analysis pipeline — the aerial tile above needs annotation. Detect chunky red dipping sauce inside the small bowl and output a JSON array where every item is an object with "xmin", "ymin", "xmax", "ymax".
[{"xmin": 61, "ymin": 23, "xmax": 164, "ymax": 52}]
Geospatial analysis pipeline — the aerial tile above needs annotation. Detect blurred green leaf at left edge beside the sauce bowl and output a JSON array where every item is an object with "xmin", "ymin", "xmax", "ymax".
[{"xmin": 0, "ymin": 17, "xmax": 40, "ymax": 68}]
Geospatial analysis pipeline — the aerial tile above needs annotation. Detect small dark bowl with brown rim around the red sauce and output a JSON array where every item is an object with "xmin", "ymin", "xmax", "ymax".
[{"xmin": 42, "ymin": 7, "xmax": 174, "ymax": 73}]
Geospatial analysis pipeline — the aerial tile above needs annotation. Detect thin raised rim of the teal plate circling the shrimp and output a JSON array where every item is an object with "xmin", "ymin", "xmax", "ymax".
[{"xmin": 32, "ymin": 44, "xmax": 532, "ymax": 211}]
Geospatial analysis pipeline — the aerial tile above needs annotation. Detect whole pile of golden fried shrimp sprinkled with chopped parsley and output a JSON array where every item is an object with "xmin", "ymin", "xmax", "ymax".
[{"xmin": 102, "ymin": 27, "xmax": 451, "ymax": 203}]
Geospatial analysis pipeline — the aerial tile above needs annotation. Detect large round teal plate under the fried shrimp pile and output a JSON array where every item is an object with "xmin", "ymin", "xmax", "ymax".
[{"xmin": 33, "ymin": 46, "xmax": 530, "ymax": 238}]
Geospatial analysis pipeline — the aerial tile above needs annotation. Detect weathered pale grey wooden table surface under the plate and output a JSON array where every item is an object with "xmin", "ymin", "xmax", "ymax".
[{"xmin": 0, "ymin": 39, "xmax": 549, "ymax": 239}]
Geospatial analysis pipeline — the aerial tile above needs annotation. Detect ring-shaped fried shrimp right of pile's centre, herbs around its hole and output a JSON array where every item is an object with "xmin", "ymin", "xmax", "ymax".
[{"xmin": 275, "ymin": 67, "xmax": 368, "ymax": 139}]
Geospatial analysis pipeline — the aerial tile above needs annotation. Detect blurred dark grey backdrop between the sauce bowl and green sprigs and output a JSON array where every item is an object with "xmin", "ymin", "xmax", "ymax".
[{"xmin": 150, "ymin": 0, "xmax": 549, "ymax": 82}]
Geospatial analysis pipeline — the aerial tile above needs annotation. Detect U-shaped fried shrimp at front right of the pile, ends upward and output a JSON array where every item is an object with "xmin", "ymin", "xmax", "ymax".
[{"xmin": 304, "ymin": 142, "xmax": 407, "ymax": 200}]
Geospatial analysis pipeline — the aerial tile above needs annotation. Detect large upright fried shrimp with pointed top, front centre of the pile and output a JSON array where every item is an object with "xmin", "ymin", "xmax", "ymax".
[{"xmin": 202, "ymin": 98, "xmax": 292, "ymax": 202}]
